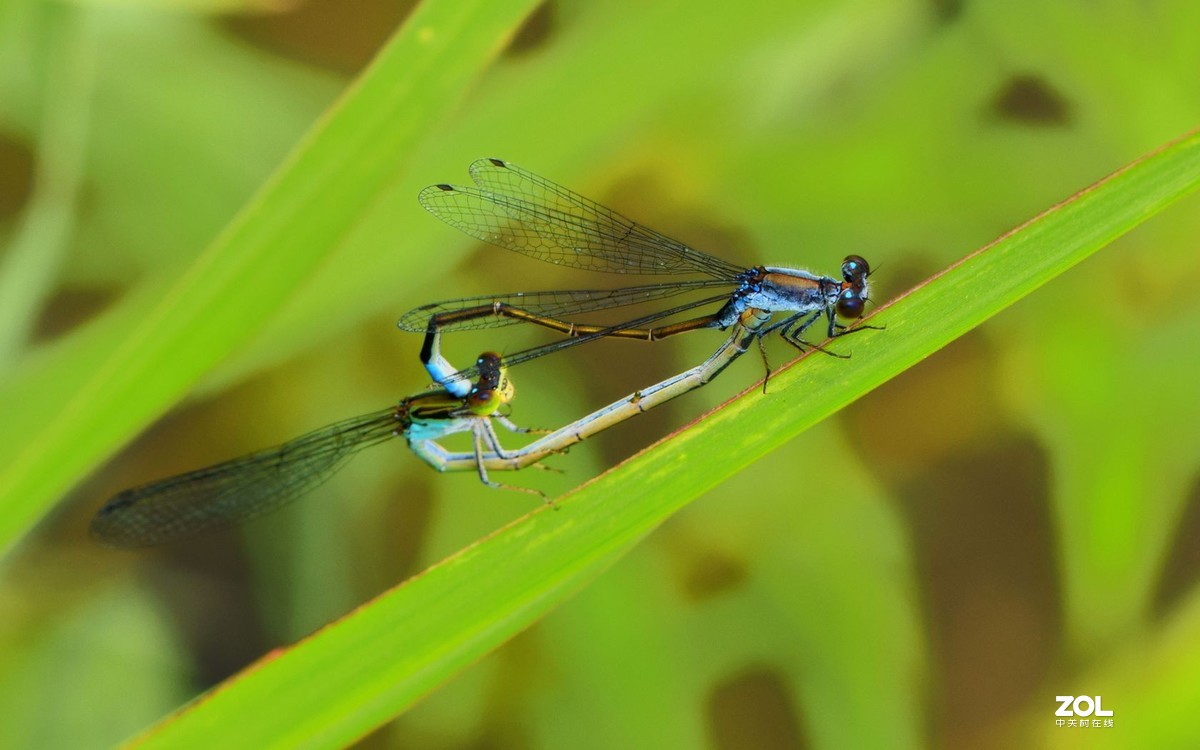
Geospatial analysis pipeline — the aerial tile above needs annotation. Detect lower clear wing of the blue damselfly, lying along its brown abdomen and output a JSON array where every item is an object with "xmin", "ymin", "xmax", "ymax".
[{"xmin": 398, "ymin": 278, "xmax": 731, "ymax": 334}]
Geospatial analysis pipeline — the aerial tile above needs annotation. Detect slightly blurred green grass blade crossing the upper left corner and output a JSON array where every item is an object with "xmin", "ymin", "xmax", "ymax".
[{"xmin": 0, "ymin": 0, "xmax": 535, "ymax": 550}]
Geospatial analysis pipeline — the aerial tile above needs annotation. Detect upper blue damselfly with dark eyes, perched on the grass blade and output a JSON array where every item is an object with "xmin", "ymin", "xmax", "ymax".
[{"xmin": 400, "ymin": 158, "xmax": 875, "ymax": 395}]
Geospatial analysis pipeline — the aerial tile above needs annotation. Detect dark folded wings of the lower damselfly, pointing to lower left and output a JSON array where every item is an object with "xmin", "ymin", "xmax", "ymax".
[{"xmin": 91, "ymin": 408, "xmax": 397, "ymax": 547}]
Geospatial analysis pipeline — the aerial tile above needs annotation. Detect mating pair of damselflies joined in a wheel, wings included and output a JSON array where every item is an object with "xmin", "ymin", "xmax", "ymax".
[{"xmin": 91, "ymin": 158, "xmax": 875, "ymax": 546}]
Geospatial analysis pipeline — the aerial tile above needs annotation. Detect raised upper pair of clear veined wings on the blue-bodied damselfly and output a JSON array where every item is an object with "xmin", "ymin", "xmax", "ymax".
[{"xmin": 420, "ymin": 158, "xmax": 745, "ymax": 281}]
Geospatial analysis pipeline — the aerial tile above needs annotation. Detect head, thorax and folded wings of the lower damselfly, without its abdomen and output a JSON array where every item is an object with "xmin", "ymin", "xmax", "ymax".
[{"xmin": 91, "ymin": 353, "xmax": 541, "ymax": 547}]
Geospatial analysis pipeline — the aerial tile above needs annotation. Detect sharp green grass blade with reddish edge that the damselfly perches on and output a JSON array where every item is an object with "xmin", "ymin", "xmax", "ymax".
[{"xmin": 131, "ymin": 133, "xmax": 1200, "ymax": 748}]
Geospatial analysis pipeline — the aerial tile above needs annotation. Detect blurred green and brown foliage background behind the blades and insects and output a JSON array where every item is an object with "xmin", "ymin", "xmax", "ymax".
[{"xmin": 0, "ymin": 0, "xmax": 1200, "ymax": 748}]
